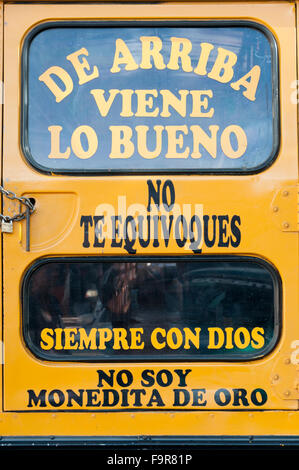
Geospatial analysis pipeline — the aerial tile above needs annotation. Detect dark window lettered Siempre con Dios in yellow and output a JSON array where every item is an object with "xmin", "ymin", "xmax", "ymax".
[{"xmin": 23, "ymin": 257, "xmax": 280, "ymax": 361}]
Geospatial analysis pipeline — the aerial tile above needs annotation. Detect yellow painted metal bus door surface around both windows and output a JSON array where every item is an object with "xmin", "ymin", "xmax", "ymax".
[{"xmin": 0, "ymin": 2, "xmax": 299, "ymax": 436}]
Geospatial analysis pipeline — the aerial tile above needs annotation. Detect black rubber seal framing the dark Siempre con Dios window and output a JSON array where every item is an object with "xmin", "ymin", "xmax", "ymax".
[{"xmin": 21, "ymin": 255, "xmax": 282, "ymax": 364}]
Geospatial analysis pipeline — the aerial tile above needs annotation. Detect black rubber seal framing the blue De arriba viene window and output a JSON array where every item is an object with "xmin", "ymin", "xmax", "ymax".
[{"xmin": 20, "ymin": 19, "xmax": 281, "ymax": 176}]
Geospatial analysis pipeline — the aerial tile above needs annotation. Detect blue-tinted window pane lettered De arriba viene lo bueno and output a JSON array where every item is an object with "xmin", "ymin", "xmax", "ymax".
[{"xmin": 22, "ymin": 22, "xmax": 279, "ymax": 174}]
